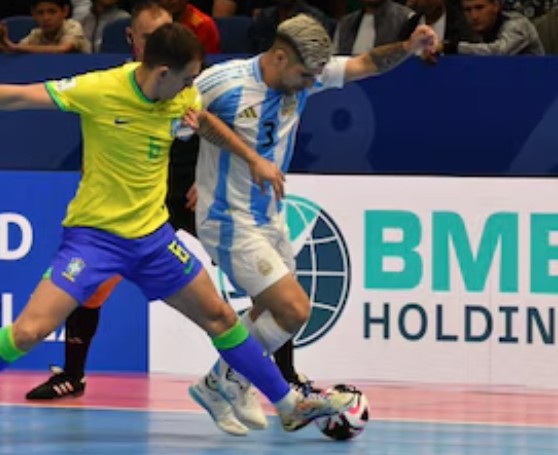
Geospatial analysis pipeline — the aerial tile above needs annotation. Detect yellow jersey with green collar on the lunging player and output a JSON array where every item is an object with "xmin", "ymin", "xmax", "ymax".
[{"xmin": 45, "ymin": 63, "xmax": 201, "ymax": 238}]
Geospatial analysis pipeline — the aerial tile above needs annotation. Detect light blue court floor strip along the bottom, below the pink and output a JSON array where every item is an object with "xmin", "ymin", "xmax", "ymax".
[{"xmin": 0, "ymin": 406, "xmax": 558, "ymax": 455}]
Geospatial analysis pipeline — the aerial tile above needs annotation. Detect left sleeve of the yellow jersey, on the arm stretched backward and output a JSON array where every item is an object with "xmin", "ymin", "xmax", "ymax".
[{"xmin": 45, "ymin": 72, "xmax": 103, "ymax": 115}]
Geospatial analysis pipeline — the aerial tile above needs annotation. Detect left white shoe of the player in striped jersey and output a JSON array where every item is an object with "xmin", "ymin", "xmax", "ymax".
[{"xmin": 188, "ymin": 376, "xmax": 249, "ymax": 436}]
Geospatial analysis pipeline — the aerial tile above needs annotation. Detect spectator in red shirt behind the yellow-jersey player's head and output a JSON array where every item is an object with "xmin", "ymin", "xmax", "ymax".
[{"xmin": 160, "ymin": 0, "xmax": 221, "ymax": 54}]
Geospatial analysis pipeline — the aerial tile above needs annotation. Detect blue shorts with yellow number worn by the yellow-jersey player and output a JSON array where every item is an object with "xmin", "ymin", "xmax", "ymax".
[{"xmin": 49, "ymin": 223, "xmax": 202, "ymax": 303}]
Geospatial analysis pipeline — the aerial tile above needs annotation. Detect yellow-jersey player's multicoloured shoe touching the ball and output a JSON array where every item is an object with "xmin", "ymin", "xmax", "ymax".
[{"xmin": 278, "ymin": 389, "xmax": 354, "ymax": 431}]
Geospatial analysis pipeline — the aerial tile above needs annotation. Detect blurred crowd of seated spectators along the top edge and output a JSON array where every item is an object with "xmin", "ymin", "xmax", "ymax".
[{"xmin": 0, "ymin": 0, "xmax": 558, "ymax": 55}]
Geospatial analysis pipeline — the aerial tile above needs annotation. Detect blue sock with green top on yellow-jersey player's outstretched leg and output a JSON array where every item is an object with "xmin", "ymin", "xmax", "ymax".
[{"xmin": 213, "ymin": 322, "xmax": 291, "ymax": 403}]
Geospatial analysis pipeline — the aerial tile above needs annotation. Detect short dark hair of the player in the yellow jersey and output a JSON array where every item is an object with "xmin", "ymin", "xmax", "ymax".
[{"xmin": 143, "ymin": 22, "xmax": 204, "ymax": 70}]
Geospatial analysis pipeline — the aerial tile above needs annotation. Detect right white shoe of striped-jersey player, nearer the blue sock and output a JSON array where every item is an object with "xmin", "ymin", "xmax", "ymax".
[{"xmin": 219, "ymin": 365, "xmax": 268, "ymax": 430}]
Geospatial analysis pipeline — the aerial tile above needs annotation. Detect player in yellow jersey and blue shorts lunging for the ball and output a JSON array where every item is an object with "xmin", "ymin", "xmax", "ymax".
[{"xmin": 0, "ymin": 24, "xmax": 352, "ymax": 434}]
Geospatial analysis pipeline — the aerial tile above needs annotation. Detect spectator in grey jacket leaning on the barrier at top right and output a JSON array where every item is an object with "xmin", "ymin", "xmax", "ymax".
[{"xmin": 440, "ymin": 0, "xmax": 544, "ymax": 55}]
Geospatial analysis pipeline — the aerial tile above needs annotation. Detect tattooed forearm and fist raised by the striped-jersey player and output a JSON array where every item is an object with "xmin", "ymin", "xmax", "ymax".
[{"xmin": 345, "ymin": 25, "xmax": 438, "ymax": 82}]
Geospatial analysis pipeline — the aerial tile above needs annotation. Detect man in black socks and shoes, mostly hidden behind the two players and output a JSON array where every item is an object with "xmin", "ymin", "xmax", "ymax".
[{"xmin": 26, "ymin": 0, "xmax": 318, "ymax": 410}]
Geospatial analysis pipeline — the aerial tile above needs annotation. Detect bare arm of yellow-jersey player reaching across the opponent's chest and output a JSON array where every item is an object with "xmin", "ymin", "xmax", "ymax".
[{"xmin": 185, "ymin": 111, "xmax": 285, "ymax": 199}]
